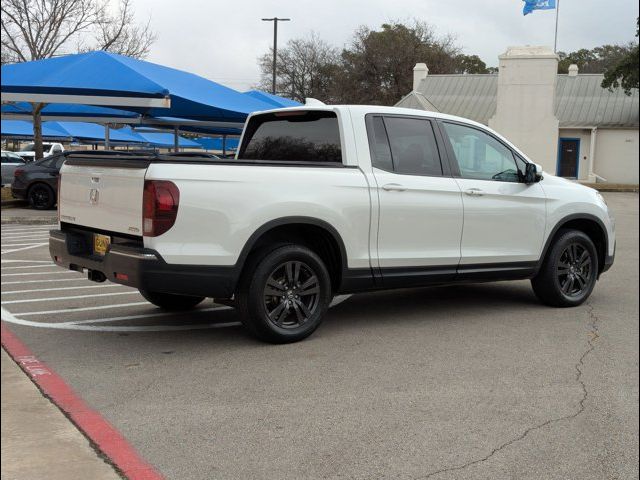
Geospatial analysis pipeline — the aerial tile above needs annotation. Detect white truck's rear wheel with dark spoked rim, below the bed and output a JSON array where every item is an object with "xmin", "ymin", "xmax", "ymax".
[{"xmin": 237, "ymin": 245, "xmax": 332, "ymax": 343}]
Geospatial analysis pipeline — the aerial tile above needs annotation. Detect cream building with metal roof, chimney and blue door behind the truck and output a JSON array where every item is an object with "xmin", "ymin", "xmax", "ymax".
[{"xmin": 396, "ymin": 47, "xmax": 639, "ymax": 184}]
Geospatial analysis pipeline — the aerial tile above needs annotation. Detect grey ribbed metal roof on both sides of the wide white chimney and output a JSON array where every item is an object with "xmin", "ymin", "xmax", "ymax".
[{"xmin": 396, "ymin": 74, "xmax": 639, "ymax": 128}]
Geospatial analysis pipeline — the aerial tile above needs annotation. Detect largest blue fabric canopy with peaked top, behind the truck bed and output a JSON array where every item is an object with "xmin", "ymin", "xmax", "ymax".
[{"xmin": 0, "ymin": 51, "xmax": 274, "ymax": 151}]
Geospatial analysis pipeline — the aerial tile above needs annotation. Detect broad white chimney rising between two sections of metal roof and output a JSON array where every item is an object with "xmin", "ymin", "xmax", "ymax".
[{"xmin": 489, "ymin": 46, "xmax": 559, "ymax": 174}]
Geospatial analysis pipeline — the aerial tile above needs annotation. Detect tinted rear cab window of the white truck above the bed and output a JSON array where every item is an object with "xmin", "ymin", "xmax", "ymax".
[{"xmin": 238, "ymin": 111, "xmax": 342, "ymax": 163}]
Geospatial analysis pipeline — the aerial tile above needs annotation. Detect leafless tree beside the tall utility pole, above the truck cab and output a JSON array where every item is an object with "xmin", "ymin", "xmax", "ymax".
[{"xmin": 258, "ymin": 33, "xmax": 339, "ymax": 102}]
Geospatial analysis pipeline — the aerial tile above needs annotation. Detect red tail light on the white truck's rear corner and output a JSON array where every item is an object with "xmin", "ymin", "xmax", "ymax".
[{"xmin": 142, "ymin": 180, "xmax": 180, "ymax": 237}]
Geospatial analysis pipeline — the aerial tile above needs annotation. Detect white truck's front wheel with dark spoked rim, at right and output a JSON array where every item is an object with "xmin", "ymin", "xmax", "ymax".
[{"xmin": 531, "ymin": 230, "xmax": 599, "ymax": 307}]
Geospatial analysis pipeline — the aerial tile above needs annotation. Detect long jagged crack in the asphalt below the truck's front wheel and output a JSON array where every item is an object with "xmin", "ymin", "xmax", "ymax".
[{"xmin": 416, "ymin": 302, "xmax": 600, "ymax": 480}]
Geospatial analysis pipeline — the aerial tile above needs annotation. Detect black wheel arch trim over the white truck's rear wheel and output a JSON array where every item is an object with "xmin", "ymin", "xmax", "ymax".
[{"xmin": 236, "ymin": 216, "xmax": 347, "ymax": 291}]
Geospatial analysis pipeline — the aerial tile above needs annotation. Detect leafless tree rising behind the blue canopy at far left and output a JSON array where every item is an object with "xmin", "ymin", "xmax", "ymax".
[{"xmin": 0, "ymin": 0, "xmax": 155, "ymax": 158}]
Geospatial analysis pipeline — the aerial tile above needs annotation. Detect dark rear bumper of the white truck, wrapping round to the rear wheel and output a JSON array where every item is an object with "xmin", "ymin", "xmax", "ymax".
[{"xmin": 49, "ymin": 230, "xmax": 238, "ymax": 298}]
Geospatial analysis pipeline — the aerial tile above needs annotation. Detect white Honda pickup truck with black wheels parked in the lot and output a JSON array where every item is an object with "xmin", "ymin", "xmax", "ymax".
[{"xmin": 50, "ymin": 106, "xmax": 615, "ymax": 342}]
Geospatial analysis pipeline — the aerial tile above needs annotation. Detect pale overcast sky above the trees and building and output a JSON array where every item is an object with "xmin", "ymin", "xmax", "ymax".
[{"xmin": 134, "ymin": 0, "xmax": 638, "ymax": 90}]
